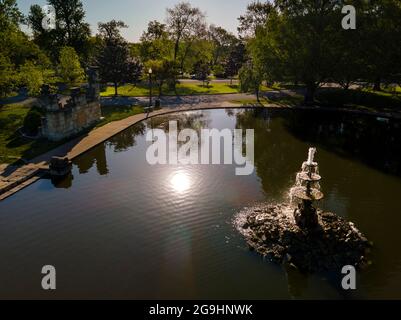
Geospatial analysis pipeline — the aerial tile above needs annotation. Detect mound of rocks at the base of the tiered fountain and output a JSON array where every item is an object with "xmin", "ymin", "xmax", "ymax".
[{"xmin": 234, "ymin": 205, "xmax": 371, "ymax": 273}]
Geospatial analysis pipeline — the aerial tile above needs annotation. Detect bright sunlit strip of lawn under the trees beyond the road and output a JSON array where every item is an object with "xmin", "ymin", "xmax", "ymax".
[{"xmin": 101, "ymin": 82, "xmax": 272, "ymax": 97}]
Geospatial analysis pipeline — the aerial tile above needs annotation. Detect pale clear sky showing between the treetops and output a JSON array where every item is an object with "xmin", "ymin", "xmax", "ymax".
[{"xmin": 17, "ymin": 0, "xmax": 252, "ymax": 42}]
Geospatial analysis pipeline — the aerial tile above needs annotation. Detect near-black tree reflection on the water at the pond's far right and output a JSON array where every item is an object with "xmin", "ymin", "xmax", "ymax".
[{"xmin": 286, "ymin": 111, "xmax": 401, "ymax": 175}]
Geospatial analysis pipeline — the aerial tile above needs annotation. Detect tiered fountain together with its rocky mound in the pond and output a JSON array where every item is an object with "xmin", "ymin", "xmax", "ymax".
[{"xmin": 234, "ymin": 148, "xmax": 372, "ymax": 273}]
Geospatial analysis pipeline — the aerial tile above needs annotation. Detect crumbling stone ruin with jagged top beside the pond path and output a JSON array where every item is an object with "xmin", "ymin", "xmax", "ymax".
[{"xmin": 39, "ymin": 67, "xmax": 101, "ymax": 141}]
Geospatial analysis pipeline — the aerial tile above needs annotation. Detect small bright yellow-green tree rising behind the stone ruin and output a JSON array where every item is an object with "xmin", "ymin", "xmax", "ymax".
[{"xmin": 59, "ymin": 47, "xmax": 85, "ymax": 85}]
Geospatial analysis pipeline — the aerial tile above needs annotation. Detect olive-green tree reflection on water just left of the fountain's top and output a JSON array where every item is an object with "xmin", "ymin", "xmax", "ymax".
[{"xmin": 236, "ymin": 109, "xmax": 306, "ymax": 200}]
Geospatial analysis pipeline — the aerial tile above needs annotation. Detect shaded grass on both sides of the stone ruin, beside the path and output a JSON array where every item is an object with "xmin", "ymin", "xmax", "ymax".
[{"xmin": 0, "ymin": 104, "xmax": 143, "ymax": 164}]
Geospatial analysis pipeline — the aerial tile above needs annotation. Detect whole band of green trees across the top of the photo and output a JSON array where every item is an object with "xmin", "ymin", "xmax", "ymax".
[{"xmin": 0, "ymin": 0, "xmax": 401, "ymax": 104}]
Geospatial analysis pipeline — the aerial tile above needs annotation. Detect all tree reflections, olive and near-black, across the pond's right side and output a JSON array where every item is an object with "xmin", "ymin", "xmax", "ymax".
[{"xmin": 236, "ymin": 109, "xmax": 401, "ymax": 197}]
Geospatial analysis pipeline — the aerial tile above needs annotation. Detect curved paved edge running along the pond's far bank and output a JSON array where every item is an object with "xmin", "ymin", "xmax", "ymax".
[{"xmin": 0, "ymin": 101, "xmax": 401, "ymax": 201}]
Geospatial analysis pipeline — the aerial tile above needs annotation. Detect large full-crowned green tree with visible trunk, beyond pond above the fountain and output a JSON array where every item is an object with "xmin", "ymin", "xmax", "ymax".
[{"xmin": 249, "ymin": 0, "xmax": 343, "ymax": 104}]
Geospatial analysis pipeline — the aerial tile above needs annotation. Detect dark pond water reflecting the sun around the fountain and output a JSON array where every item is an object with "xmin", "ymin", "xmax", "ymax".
[{"xmin": 0, "ymin": 109, "xmax": 401, "ymax": 299}]
